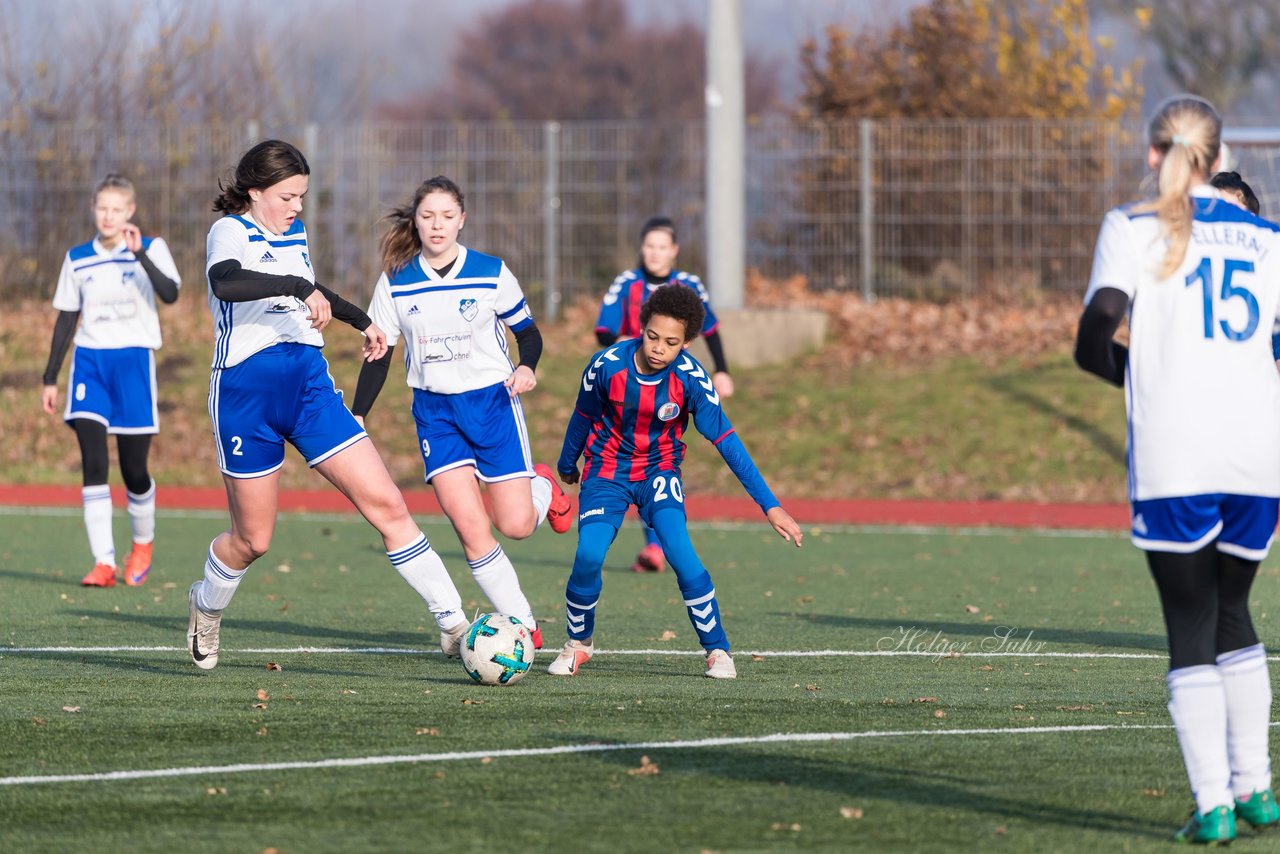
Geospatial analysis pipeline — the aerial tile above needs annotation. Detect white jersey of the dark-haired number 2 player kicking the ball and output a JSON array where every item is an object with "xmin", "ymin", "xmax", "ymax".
[{"xmin": 205, "ymin": 214, "xmax": 324, "ymax": 369}]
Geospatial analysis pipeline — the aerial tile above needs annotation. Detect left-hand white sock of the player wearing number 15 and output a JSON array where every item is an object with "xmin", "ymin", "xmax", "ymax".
[{"xmin": 1166, "ymin": 665, "xmax": 1235, "ymax": 816}]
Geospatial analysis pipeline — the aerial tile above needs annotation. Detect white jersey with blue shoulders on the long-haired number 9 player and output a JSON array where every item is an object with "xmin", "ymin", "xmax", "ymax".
[{"xmin": 369, "ymin": 246, "xmax": 534, "ymax": 394}]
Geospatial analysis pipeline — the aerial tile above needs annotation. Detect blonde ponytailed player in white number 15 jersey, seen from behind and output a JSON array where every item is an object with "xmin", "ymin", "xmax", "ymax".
[{"xmin": 1075, "ymin": 96, "xmax": 1280, "ymax": 842}]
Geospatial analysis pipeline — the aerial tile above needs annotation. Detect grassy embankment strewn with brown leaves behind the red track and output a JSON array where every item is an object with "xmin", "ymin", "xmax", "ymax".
[{"xmin": 0, "ymin": 293, "xmax": 1124, "ymax": 501}]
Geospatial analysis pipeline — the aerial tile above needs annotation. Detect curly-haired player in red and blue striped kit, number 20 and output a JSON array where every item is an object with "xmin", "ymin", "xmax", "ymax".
[{"xmin": 547, "ymin": 288, "xmax": 803, "ymax": 679}]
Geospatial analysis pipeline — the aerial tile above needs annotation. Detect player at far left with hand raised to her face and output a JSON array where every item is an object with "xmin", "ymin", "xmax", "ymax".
[{"xmin": 40, "ymin": 173, "xmax": 182, "ymax": 588}]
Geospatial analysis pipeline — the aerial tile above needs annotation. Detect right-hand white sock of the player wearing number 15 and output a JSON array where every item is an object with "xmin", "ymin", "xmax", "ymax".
[{"xmin": 1217, "ymin": 644, "xmax": 1271, "ymax": 800}]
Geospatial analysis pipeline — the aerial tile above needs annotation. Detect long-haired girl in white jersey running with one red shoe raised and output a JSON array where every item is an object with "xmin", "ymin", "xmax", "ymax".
[{"xmin": 352, "ymin": 175, "xmax": 573, "ymax": 648}]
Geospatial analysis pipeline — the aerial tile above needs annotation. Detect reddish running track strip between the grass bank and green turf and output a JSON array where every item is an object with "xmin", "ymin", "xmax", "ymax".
[{"xmin": 0, "ymin": 485, "xmax": 1129, "ymax": 531}]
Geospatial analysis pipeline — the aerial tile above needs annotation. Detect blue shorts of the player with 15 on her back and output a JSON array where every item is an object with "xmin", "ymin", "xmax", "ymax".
[{"xmin": 1133, "ymin": 493, "xmax": 1280, "ymax": 561}]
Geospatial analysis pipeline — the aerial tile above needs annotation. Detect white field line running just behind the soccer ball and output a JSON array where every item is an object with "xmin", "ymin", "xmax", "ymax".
[{"xmin": 0, "ymin": 647, "xmax": 1187, "ymax": 661}]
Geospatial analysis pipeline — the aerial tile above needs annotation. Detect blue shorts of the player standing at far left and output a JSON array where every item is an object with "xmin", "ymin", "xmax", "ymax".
[{"xmin": 63, "ymin": 347, "xmax": 160, "ymax": 434}]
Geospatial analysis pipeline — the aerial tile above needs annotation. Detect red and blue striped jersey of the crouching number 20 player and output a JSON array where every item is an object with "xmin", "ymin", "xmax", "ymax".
[{"xmin": 557, "ymin": 338, "xmax": 778, "ymax": 512}]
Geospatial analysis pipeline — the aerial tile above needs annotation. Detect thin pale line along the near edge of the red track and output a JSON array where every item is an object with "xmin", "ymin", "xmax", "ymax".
[{"xmin": 0, "ymin": 504, "xmax": 1129, "ymax": 539}]
